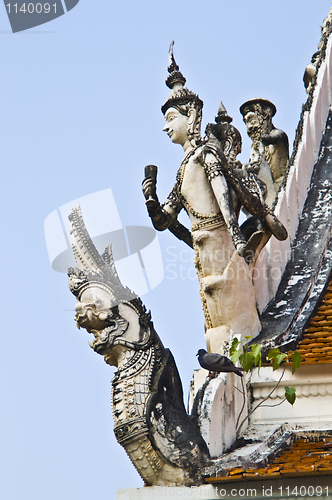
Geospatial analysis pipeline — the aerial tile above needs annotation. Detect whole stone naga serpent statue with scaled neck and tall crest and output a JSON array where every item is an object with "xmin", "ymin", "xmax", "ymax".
[{"xmin": 68, "ymin": 206, "xmax": 209, "ymax": 486}]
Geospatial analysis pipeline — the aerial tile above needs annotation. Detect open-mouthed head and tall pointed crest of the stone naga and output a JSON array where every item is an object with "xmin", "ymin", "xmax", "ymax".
[{"xmin": 68, "ymin": 206, "xmax": 154, "ymax": 366}]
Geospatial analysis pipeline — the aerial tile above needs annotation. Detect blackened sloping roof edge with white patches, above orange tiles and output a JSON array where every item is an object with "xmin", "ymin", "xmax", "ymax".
[{"xmin": 254, "ymin": 111, "xmax": 332, "ymax": 350}]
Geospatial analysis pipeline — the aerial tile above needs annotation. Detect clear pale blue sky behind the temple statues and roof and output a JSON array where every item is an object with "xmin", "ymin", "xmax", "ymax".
[{"xmin": 0, "ymin": 0, "xmax": 330, "ymax": 500}]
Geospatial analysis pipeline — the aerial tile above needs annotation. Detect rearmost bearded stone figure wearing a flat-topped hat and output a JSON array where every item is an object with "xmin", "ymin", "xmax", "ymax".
[{"xmin": 240, "ymin": 98, "xmax": 289, "ymax": 207}]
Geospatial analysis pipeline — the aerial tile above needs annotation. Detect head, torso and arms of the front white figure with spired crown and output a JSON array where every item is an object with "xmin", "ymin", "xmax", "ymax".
[{"xmin": 143, "ymin": 45, "xmax": 254, "ymax": 262}]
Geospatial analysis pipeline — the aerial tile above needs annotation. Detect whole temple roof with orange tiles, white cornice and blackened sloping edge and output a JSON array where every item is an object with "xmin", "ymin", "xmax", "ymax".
[{"xmin": 197, "ymin": 9, "xmax": 332, "ymax": 492}]
